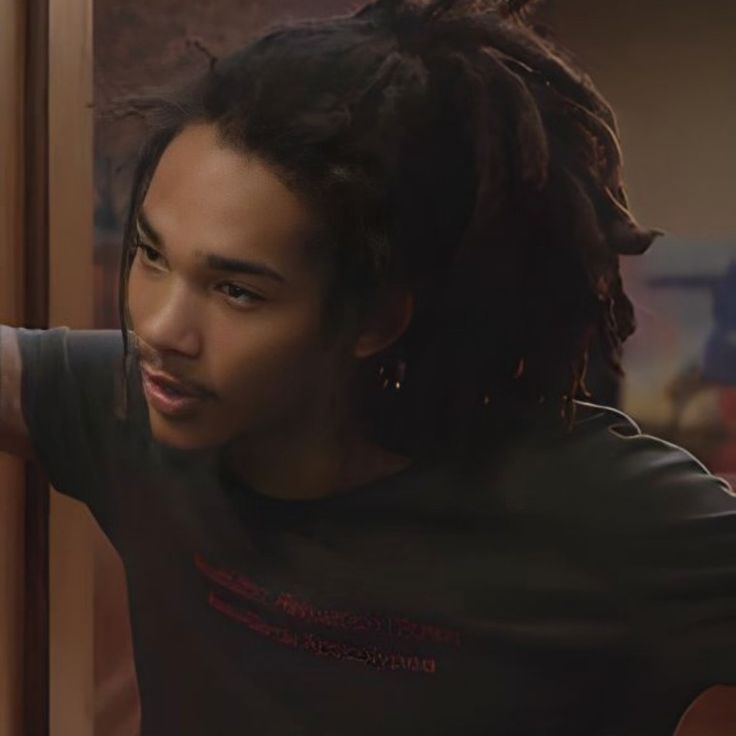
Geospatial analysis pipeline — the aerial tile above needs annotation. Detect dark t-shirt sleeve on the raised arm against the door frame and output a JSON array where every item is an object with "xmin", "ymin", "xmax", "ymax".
[{"xmin": 18, "ymin": 327, "xmax": 129, "ymax": 510}]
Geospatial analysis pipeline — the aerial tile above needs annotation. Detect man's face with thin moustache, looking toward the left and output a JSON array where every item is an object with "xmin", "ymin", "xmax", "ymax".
[{"xmin": 128, "ymin": 125, "xmax": 350, "ymax": 449}]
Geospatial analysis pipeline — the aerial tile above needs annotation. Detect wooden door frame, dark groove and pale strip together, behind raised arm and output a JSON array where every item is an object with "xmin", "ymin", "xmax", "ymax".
[{"xmin": 21, "ymin": 0, "xmax": 94, "ymax": 736}]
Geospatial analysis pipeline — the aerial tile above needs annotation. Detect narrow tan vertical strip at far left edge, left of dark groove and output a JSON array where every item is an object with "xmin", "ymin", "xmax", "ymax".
[{"xmin": 0, "ymin": 0, "xmax": 24, "ymax": 736}]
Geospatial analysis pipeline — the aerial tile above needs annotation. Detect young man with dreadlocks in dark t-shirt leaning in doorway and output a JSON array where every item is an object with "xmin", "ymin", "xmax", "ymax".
[{"xmin": 0, "ymin": 0, "xmax": 736, "ymax": 736}]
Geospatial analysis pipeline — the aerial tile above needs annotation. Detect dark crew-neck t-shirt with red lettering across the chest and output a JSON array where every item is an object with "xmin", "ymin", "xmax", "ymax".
[{"xmin": 19, "ymin": 328, "xmax": 736, "ymax": 736}]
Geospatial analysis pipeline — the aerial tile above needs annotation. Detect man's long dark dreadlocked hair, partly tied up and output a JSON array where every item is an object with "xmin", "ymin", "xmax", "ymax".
[{"xmin": 120, "ymin": 0, "xmax": 658, "ymax": 466}]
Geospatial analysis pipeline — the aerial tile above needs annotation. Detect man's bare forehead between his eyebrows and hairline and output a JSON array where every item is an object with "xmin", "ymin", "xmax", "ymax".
[{"xmin": 140, "ymin": 126, "xmax": 331, "ymax": 267}]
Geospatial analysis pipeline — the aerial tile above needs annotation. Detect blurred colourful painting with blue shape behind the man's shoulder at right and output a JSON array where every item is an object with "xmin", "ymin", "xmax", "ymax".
[{"xmin": 622, "ymin": 238, "xmax": 736, "ymax": 474}]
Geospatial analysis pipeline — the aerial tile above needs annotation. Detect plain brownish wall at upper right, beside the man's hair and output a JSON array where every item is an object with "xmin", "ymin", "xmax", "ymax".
[{"xmin": 552, "ymin": 0, "xmax": 736, "ymax": 239}]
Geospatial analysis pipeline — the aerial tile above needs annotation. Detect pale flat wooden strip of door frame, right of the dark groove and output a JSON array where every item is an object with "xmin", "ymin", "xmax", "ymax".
[{"xmin": 47, "ymin": 0, "xmax": 95, "ymax": 736}]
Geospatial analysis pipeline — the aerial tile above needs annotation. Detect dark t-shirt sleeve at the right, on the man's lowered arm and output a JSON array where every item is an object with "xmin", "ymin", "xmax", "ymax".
[{"xmin": 580, "ymin": 434, "xmax": 736, "ymax": 689}]
